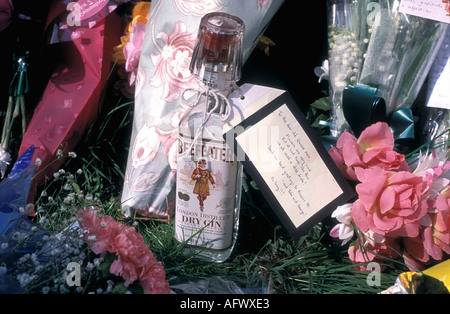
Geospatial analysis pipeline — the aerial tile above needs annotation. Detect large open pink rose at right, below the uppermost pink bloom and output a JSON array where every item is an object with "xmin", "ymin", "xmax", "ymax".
[{"xmin": 352, "ymin": 168, "xmax": 427, "ymax": 237}]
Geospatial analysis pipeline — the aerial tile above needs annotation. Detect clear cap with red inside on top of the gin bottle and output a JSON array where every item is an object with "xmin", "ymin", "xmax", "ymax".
[{"xmin": 190, "ymin": 12, "xmax": 245, "ymax": 89}]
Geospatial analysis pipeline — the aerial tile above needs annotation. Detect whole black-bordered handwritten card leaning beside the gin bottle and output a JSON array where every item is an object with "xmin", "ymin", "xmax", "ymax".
[{"xmin": 224, "ymin": 86, "xmax": 353, "ymax": 237}]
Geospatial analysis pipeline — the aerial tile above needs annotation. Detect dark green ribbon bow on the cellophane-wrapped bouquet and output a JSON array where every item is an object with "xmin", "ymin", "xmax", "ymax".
[{"xmin": 342, "ymin": 85, "xmax": 414, "ymax": 140}]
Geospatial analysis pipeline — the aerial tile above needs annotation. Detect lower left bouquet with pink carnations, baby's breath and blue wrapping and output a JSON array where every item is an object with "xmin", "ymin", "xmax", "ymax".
[{"xmin": 0, "ymin": 147, "xmax": 171, "ymax": 294}]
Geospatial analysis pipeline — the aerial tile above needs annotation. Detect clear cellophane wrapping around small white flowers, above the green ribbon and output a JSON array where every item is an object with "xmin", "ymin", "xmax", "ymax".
[{"xmin": 328, "ymin": 0, "xmax": 448, "ymax": 136}]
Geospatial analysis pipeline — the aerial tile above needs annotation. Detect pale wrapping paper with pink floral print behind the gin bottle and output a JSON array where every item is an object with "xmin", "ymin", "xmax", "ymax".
[{"xmin": 122, "ymin": 0, "xmax": 284, "ymax": 218}]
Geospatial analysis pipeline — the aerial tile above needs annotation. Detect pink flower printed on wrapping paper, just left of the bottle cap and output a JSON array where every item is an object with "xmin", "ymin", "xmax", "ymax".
[{"xmin": 150, "ymin": 21, "xmax": 197, "ymax": 101}]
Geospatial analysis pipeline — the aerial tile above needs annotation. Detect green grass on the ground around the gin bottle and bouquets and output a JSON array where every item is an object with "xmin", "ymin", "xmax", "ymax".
[{"xmin": 17, "ymin": 94, "xmax": 398, "ymax": 294}]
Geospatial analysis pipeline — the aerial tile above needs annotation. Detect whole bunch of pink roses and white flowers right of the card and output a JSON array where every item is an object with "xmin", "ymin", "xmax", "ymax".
[{"xmin": 329, "ymin": 122, "xmax": 450, "ymax": 270}]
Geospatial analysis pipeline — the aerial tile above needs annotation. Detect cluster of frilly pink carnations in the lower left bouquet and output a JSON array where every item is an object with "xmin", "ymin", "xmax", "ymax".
[{"xmin": 78, "ymin": 207, "xmax": 170, "ymax": 293}]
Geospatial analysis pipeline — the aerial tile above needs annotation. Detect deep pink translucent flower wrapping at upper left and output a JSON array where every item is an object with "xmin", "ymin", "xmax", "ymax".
[{"xmin": 19, "ymin": 0, "xmax": 123, "ymax": 200}]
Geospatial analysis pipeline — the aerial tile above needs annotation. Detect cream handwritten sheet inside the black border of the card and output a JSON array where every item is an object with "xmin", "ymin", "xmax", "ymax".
[{"xmin": 236, "ymin": 105, "xmax": 343, "ymax": 227}]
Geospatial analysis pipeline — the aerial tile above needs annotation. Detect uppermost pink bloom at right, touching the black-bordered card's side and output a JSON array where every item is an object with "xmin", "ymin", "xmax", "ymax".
[{"xmin": 329, "ymin": 122, "xmax": 409, "ymax": 181}]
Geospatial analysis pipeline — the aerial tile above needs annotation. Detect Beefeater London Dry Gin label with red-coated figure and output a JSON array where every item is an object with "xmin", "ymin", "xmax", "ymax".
[{"xmin": 175, "ymin": 133, "xmax": 238, "ymax": 250}]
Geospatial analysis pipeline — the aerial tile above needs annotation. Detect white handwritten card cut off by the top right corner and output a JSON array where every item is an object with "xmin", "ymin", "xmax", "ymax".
[{"xmin": 399, "ymin": 0, "xmax": 450, "ymax": 23}]
